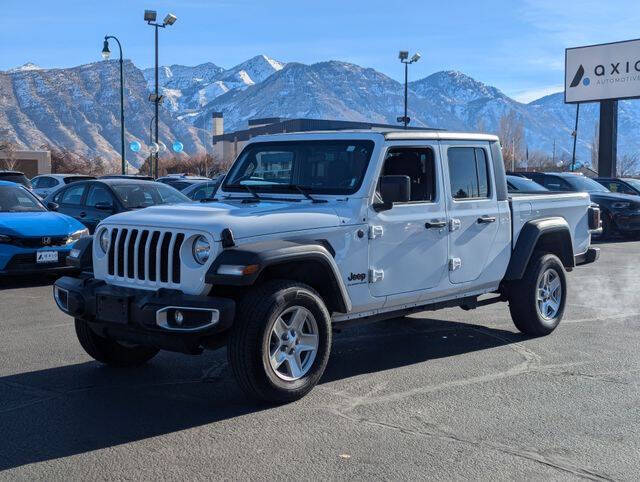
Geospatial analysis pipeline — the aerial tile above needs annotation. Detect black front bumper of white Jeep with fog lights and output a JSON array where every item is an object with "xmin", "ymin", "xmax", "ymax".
[{"xmin": 53, "ymin": 276, "xmax": 235, "ymax": 353}]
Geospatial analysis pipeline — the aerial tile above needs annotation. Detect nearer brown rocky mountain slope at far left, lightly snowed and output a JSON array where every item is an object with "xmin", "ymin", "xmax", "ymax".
[{"xmin": 0, "ymin": 60, "xmax": 207, "ymax": 164}]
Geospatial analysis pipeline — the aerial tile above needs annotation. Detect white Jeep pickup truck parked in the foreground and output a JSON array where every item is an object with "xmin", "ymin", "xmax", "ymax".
[{"xmin": 54, "ymin": 130, "xmax": 600, "ymax": 402}]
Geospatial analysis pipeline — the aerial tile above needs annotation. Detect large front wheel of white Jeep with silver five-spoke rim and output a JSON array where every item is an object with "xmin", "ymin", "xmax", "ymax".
[{"xmin": 227, "ymin": 280, "xmax": 331, "ymax": 403}]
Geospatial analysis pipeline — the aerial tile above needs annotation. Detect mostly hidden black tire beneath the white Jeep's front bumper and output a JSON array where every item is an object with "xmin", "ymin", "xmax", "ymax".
[{"xmin": 75, "ymin": 319, "xmax": 160, "ymax": 368}]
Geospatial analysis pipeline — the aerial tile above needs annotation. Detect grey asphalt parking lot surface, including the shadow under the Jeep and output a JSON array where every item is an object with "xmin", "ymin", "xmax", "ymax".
[{"xmin": 0, "ymin": 242, "xmax": 640, "ymax": 480}]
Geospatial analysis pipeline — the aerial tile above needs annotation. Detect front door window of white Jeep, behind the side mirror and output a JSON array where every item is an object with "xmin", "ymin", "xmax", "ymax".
[{"xmin": 382, "ymin": 147, "xmax": 436, "ymax": 202}]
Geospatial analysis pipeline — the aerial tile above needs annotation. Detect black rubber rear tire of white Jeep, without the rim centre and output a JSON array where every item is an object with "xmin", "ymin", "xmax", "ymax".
[{"xmin": 509, "ymin": 252, "xmax": 567, "ymax": 336}]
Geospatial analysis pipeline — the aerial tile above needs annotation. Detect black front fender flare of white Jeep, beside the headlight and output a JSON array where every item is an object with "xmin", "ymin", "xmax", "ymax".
[{"xmin": 205, "ymin": 240, "xmax": 352, "ymax": 313}]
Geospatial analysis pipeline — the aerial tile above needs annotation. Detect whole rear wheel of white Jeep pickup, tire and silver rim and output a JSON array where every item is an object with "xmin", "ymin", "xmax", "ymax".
[{"xmin": 509, "ymin": 253, "xmax": 567, "ymax": 336}]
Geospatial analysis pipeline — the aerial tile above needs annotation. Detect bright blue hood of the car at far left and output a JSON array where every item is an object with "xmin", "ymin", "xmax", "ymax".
[{"xmin": 0, "ymin": 211, "xmax": 84, "ymax": 237}]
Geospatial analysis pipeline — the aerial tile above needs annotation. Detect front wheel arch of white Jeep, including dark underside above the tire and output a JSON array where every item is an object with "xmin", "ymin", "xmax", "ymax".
[{"xmin": 206, "ymin": 240, "xmax": 352, "ymax": 313}]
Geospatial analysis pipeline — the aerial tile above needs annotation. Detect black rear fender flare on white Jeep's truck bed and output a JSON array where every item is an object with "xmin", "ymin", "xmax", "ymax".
[{"xmin": 504, "ymin": 217, "xmax": 575, "ymax": 281}]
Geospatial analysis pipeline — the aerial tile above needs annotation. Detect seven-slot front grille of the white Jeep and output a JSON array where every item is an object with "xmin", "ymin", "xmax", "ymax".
[{"xmin": 107, "ymin": 228, "xmax": 185, "ymax": 285}]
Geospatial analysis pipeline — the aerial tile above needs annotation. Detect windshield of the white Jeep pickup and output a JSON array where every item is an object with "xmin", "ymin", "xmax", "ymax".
[{"xmin": 223, "ymin": 140, "xmax": 374, "ymax": 194}]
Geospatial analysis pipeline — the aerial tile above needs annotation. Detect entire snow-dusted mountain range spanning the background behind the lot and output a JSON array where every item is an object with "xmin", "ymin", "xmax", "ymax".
[{"xmin": 0, "ymin": 55, "xmax": 640, "ymax": 163}]
